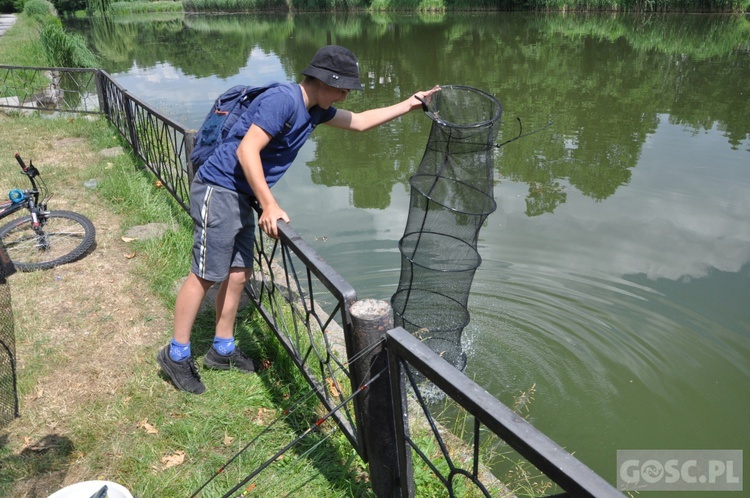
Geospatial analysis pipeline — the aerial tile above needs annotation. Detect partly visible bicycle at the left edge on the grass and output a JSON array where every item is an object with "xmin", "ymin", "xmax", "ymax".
[{"xmin": 0, "ymin": 154, "xmax": 96, "ymax": 272}]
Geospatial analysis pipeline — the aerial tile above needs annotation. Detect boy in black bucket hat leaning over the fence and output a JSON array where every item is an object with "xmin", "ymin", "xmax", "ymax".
[{"xmin": 157, "ymin": 45, "xmax": 440, "ymax": 394}]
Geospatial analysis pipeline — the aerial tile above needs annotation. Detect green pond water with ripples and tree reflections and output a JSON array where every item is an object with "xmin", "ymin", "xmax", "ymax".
[{"xmin": 69, "ymin": 13, "xmax": 750, "ymax": 497}]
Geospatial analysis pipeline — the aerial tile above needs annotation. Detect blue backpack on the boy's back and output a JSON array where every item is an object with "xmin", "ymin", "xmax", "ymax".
[{"xmin": 190, "ymin": 83, "xmax": 294, "ymax": 169}]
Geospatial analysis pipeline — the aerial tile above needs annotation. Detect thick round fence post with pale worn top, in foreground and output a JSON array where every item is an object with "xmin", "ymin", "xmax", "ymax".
[{"xmin": 349, "ymin": 299, "xmax": 400, "ymax": 498}]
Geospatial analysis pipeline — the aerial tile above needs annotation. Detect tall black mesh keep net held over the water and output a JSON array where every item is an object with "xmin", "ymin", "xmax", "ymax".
[{"xmin": 391, "ymin": 85, "xmax": 503, "ymax": 370}]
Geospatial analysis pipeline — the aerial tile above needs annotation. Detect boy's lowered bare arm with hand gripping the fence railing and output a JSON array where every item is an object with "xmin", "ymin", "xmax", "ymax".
[{"xmin": 237, "ymin": 124, "xmax": 289, "ymax": 239}]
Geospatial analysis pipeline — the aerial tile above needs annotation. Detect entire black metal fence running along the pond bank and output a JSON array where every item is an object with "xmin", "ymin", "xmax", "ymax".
[{"xmin": 0, "ymin": 66, "xmax": 622, "ymax": 497}]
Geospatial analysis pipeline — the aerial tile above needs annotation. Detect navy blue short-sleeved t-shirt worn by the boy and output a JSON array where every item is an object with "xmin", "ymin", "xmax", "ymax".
[{"xmin": 198, "ymin": 83, "xmax": 336, "ymax": 195}]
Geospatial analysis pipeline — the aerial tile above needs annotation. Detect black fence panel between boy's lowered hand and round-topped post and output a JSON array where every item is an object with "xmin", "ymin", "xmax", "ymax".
[{"xmin": 248, "ymin": 217, "xmax": 366, "ymax": 452}]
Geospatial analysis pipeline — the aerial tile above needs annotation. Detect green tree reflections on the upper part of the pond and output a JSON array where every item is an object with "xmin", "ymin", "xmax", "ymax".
[{"xmin": 66, "ymin": 14, "xmax": 750, "ymax": 216}]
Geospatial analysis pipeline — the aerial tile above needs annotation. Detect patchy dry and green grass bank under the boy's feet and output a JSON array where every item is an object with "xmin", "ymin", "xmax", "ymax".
[{"xmin": 0, "ymin": 111, "xmax": 378, "ymax": 497}]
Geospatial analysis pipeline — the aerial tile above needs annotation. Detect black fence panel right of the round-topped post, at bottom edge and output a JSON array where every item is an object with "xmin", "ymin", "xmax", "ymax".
[{"xmin": 386, "ymin": 327, "xmax": 622, "ymax": 498}]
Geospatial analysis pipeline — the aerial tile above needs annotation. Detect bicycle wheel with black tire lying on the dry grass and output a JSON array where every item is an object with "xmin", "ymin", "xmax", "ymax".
[{"xmin": 0, "ymin": 211, "xmax": 96, "ymax": 272}]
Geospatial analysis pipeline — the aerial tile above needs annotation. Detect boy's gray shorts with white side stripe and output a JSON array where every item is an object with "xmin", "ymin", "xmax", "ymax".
[{"xmin": 190, "ymin": 179, "xmax": 255, "ymax": 282}]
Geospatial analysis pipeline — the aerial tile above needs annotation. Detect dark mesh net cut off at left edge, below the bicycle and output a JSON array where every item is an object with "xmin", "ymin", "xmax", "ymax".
[{"xmin": 0, "ymin": 243, "xmax": 18, "ymax": 427}]
